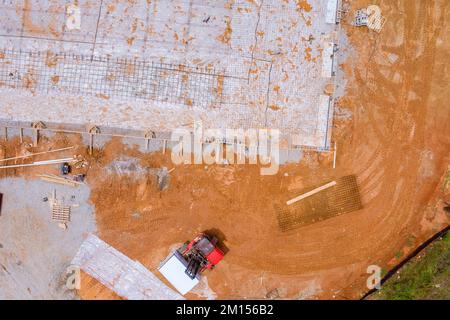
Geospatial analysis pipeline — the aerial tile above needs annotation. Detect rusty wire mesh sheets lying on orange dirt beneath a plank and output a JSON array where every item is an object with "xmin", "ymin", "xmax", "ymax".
[{"xmin": 275, "ymin": 175, "xmax": 362, "ymax": 231}]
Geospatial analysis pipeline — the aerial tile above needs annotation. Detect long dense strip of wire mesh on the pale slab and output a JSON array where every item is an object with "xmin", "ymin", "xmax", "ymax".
[{"xmin": 0, "ymin": 50, "xmax": 226, "ymax": 107}]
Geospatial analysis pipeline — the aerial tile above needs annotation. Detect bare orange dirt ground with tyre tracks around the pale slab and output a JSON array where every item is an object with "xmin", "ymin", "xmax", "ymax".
[{"xmin": 0, "ymin": 0, "xmax": 450, "ymax": 299}]
